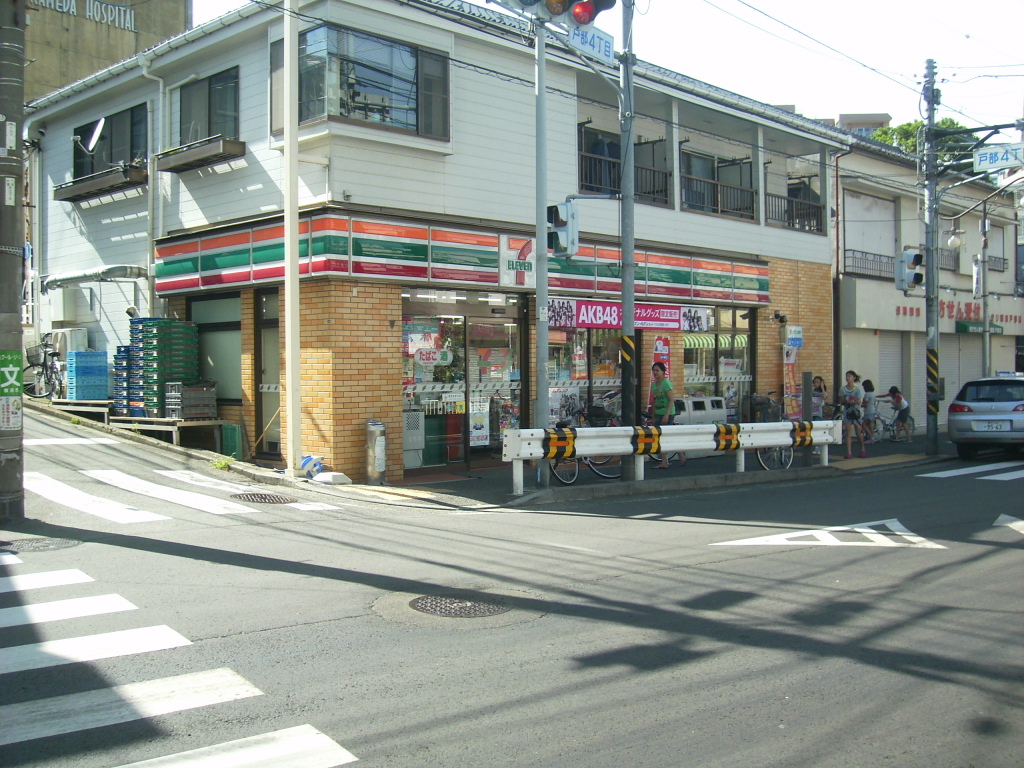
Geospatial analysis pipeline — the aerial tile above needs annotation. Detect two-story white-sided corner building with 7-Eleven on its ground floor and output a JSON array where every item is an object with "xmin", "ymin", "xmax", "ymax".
[{"xmin": 27, "ymin": 0, "xmax": 849, "ymax": 481}]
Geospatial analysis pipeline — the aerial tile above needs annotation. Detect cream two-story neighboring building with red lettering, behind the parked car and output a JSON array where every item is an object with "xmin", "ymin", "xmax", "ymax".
[{"xmin": 835, "ymin": 139, "xmax": 1024, "ymax": 426}]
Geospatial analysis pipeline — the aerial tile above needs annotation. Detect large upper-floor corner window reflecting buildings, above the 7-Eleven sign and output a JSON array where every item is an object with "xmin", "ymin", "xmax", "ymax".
[{"xmin": 270, "ymin": 27, "xmax": 450, "ymax": 139}]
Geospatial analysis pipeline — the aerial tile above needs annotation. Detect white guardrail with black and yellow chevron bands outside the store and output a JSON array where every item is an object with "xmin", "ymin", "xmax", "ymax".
[{"xmin": 502, "ymin": 421, "xmax": 842, "ymax": 496}]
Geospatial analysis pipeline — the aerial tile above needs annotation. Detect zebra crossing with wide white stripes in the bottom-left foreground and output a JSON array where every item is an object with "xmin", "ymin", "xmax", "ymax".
[{"xmin": 0, "ymin": 552, "xmax": 356, "ymax": 768}]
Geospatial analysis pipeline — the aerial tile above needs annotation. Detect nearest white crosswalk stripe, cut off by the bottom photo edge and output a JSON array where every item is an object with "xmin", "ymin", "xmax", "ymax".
[{"xmin": 111, "ymin": 725, "xmax": 356, "ymax": 768}]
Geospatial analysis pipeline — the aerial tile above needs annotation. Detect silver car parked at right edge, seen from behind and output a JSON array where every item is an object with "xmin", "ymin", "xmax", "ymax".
[{"xmin": 947, "ymin": 376, "xmax": 1024, "ymax": 459}]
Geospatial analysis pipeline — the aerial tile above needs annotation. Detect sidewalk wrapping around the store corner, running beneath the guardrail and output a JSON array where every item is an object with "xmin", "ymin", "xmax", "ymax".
[{"xmin": 26, "ymin": 400, "xmax": 955, "ymax": 509}]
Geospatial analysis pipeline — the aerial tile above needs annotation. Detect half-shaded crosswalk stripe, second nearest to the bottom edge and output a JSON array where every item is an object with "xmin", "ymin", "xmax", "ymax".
[{"xmin": 0, "ymin": 669, "xmax": 263, "ymax": 746}]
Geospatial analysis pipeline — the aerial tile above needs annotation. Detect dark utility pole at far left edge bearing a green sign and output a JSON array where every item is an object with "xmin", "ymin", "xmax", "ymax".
[{"xmin": 0, "ymin": 0, "xmax": 26, "ymax": 524}]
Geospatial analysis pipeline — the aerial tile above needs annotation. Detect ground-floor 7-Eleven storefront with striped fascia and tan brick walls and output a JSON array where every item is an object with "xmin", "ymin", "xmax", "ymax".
[{"xmin": 156, "ymin": 211, "xmax": 769, "ymax": 482}]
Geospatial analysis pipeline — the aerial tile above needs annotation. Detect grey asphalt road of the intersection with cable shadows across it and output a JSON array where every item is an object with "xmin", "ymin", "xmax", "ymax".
[{"xmin": 0, "ymin": 416, "xmax": 1024, "ymax": 768}]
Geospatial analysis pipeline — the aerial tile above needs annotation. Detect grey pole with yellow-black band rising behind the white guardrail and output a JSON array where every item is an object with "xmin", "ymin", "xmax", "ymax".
[{"xmin": 618, "ymin": 0, "xmax": 637, "ymax": 480}]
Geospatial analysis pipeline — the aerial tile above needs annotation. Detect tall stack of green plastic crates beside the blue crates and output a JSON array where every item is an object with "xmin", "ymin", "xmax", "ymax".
[{"xmin": 128, "ymin": 317, "xmax": 199, "ymax": 419}]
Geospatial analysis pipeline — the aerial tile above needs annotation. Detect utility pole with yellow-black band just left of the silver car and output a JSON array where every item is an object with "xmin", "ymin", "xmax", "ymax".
[{"xmin": 923, "ymin": 58, "xmax": 941, "ymax": 456}]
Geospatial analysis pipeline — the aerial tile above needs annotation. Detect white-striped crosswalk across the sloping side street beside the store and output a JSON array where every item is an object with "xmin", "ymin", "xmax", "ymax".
[{"xmin": 24, "ymin": 469, "xmax": 341, "ymax": 525}]
